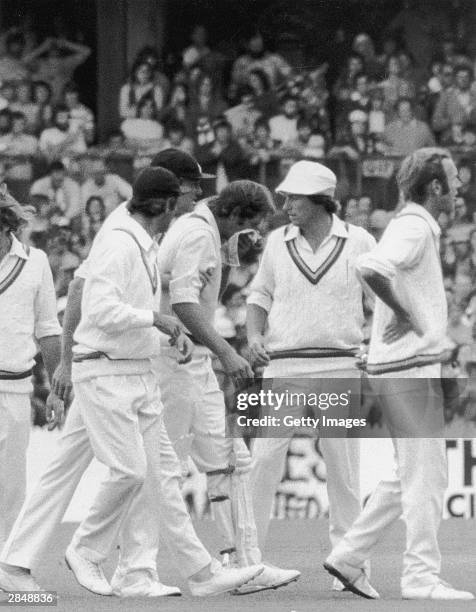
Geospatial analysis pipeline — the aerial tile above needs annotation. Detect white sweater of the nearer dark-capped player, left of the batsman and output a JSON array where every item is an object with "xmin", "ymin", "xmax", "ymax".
[{"xmin": 73, "ymin": 205, "xmax": 160, "ymax": 373}]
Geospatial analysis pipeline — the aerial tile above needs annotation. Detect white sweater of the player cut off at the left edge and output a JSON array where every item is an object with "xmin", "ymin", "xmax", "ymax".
[{"xmin": 0, "ymin": 236, "xmax": 61, "ymax": 392}]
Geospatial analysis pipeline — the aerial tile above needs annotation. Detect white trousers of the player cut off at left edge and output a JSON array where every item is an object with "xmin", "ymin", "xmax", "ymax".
[{"xmin": 0, "ymin": 391, "xmax": 31, "ymax": 550}]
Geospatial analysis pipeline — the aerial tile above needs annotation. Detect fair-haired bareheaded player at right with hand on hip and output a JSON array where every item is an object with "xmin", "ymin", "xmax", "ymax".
[{"xmin": 324, "ymin": 148, "xmax": 473, "ymax": 600}]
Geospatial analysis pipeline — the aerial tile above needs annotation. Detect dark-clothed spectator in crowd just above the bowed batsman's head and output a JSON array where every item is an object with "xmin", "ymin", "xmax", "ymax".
[{"xmin": 196, "ymin": 118, "xmax": 249, "ymax": 193}]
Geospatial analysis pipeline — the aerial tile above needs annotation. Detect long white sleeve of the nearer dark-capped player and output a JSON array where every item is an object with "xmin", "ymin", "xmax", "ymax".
[{"xmin": 83, "ymin": 236, "xmax": 154, "ymax": 333}]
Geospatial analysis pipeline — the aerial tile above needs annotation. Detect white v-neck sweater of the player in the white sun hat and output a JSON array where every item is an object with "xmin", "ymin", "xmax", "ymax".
[{"xmin": 248, "ymin": 215, "xmax": 375, "ymax": 351}]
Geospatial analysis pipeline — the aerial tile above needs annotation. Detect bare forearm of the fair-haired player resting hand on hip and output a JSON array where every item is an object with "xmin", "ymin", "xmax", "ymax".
[{"xmin": 361, "ymin": 268, "xmax": 423, "ymax": 344}]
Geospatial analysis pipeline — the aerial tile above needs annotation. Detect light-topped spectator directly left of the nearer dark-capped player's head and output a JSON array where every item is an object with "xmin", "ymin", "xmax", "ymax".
[{"xmin": 81, "ymin": 157, "xmax": 132, "ymax": 215}]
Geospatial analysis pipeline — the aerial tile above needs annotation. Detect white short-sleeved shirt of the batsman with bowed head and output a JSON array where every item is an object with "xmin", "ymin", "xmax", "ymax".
[{"xmin": 159, "ymin": 200, "xmax": 221, "ymax": 324}]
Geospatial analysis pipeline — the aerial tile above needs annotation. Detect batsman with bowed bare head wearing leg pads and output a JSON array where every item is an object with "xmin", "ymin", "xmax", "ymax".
[{"xmin": 156, "ymin": 180, "xmax": 300, "ymax": 593}]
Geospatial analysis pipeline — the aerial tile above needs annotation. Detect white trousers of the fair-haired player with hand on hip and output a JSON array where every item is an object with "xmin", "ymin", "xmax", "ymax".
[{"xmin": 332, "ymin": 366, "xmax": 447, "ymax": 590}]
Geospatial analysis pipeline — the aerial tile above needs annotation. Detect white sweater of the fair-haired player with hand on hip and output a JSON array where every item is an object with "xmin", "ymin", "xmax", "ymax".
[{"xmin": 358, "ymin": 202, "xmax": 448, "ymax": 376}]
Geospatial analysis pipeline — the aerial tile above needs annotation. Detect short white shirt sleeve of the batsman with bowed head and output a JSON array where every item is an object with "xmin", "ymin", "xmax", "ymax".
[{"xmin": 169, "ymin": 230, "xmax": 218, "ymax": 304}]
